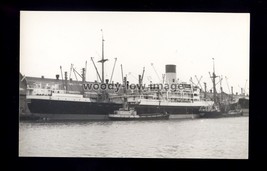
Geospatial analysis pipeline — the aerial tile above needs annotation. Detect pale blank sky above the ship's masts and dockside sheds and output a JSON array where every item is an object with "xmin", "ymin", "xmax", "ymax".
[{"xmin": 20, "ymin": 11, "xmax": 250, "ymax": 94}]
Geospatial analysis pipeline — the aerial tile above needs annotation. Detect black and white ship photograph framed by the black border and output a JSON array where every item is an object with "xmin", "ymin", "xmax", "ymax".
[{"xmin": 18, "ymin": 10, "xmax": 250, "ymax": 159}]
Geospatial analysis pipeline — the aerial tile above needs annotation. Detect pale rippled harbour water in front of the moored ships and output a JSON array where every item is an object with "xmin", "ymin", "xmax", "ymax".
[{"xmin": 19, "ymin": 116, "xmax": 249, "ymax": 159}]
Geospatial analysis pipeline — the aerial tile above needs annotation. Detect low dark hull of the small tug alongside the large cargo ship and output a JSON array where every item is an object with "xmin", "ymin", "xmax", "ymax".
[{"xmin": 109, "ymin": 115, "xmax": 170, "ymax": 121}]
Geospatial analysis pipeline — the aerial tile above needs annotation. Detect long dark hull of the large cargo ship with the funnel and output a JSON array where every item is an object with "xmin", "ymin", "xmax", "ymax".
[{"xmin": 27, "ymin": 99, "xmax": 204, "ymax": 120}]
